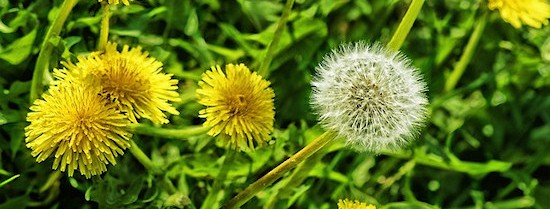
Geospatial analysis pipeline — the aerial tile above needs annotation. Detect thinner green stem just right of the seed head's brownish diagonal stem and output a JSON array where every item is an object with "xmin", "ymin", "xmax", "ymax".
[{"xmin": 264, "ymin": 137, "xmax": 337, "ymax": 209}]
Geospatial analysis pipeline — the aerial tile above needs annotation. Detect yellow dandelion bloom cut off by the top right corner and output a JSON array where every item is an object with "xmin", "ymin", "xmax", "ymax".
[{"xmin": 487, "ymin": 0, "xmax": 550, "ymax": 28}]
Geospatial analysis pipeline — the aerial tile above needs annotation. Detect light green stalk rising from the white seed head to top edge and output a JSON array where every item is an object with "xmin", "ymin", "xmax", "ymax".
[{"xmin": 387, "ymin": 0, "xmax": 430, "ymax": 51}]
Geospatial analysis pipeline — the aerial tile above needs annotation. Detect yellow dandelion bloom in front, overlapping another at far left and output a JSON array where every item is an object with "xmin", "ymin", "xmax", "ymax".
[{"xmin": 25, "ymin": 82, "xmax": 131, "ymax": 178}]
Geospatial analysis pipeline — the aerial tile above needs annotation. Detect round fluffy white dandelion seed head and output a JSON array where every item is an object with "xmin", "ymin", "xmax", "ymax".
[{"xmin": 311, "ymin": 42, "xmax": 428, "ymax": 152}]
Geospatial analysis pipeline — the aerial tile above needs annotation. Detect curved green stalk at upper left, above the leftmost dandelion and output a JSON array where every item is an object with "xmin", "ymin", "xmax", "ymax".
[{"xmin": 29, "ymin": 0, "xmax": 77, "ymax": 103}]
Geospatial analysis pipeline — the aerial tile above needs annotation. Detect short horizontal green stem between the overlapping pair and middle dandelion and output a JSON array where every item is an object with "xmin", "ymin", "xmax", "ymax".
[{"xmin": 132, "ymin": 124, "xmax": 210, "ymax": 139}]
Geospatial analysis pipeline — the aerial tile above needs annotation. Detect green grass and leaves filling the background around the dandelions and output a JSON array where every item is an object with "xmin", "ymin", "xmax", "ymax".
[{"xmin": 0, "ymin": 0, "xmax": 550, "ymax": 209}]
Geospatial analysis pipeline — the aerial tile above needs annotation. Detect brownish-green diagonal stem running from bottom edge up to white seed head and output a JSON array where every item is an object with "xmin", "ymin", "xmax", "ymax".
[{"xmin": 222, "ymin": 131, "xmax": 336, "ymax": 209}]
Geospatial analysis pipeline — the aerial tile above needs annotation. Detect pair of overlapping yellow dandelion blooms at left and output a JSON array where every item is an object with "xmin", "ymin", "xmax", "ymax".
[{"xmin": 25, "ymin": 44, "xmax": 179, "ymax": 178}]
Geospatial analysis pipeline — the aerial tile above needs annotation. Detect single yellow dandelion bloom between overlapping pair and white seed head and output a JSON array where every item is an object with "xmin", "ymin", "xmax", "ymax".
[{"xmin": 197, "ymin": 64, "xmax": 275, "ymax": 150}]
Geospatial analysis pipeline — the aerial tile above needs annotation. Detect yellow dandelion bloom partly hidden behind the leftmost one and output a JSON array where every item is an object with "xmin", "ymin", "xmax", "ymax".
[{"xmin": 56, "ymin": 43, "xmax": 180, "ymax": 124}]
